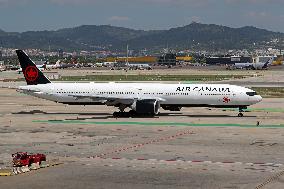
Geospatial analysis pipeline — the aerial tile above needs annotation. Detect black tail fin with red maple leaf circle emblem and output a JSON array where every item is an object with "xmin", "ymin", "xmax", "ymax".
[{"xmin": 16, "ymin": 50, "xmax": 51, "ymax": 85}]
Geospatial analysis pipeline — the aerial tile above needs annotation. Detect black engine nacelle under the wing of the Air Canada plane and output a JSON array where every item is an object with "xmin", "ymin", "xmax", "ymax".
[{"xmin": 131, "ymin": 100, "xmax": 160, "ymax": 115}]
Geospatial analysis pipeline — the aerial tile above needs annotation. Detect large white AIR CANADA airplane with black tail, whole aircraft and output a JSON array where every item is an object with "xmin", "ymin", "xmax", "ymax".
[{"xmin": 16, "ymin": 50, "xmax": 262, "ymax": 117}]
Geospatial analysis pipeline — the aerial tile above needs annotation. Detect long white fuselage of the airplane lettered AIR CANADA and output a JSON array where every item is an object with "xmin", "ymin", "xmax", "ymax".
[{"xmin": 20, "ymin": 83, "xmax": 262, "ymax": 107}]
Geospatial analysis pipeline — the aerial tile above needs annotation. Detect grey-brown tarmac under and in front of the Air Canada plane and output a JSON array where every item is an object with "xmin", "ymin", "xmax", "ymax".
[{"xmin": 0, "ymin": 68, "xmax": 284, "ymax": 189}]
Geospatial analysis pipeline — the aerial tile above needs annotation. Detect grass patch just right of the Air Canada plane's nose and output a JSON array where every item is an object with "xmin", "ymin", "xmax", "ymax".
[{"xmin": 251, "ymin": 87, "xmax": 284, "ymax": 98}]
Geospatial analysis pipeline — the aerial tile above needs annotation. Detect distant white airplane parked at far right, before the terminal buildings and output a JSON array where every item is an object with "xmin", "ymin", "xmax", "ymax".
[{"xmin": 230, "ymin": 57, "xmax": 274, "ymax": 70}]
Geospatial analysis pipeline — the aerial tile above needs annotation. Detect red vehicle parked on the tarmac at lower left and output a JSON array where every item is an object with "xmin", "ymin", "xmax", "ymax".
[{"xmin": 12, "ymin": 152, "xmax": 46, "ymax": 167}]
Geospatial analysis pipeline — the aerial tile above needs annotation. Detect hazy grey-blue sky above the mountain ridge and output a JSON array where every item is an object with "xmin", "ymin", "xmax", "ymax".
[{"xmin": 0, "ymin": 0, "xmax": 284, "ymax": 32}]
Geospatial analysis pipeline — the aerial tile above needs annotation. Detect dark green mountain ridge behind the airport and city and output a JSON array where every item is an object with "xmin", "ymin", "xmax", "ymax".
[{"xmin": 0, "ymin": 22, "xmax": 284, "ymax": 51}]
